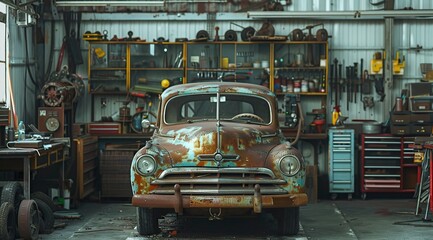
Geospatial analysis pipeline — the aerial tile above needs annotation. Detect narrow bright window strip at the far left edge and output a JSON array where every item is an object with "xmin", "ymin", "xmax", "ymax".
[{"xmin": 0, "ymin": 3, "xmax": 7, "ymax": 102}]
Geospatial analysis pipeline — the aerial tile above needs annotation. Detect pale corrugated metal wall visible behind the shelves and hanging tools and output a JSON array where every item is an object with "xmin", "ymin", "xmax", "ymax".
[{"xmin": 5, "ymin": 0, "xmax": 433, "ymax": 126}]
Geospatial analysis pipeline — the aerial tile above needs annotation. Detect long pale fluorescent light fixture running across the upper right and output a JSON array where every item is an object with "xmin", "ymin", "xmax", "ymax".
[{"xmin": 247, "ymin": 10, "xmax": 433, "ymax": 20}]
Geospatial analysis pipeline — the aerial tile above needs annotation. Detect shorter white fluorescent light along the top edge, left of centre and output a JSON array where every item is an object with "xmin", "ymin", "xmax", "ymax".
[{"xmin": 56, "ymin": 0, "xmax": 164, "ymax": 7}]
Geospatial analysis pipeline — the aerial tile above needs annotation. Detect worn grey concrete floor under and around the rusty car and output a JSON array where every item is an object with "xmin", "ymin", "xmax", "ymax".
[{"xmin": 40, "ymin": 198, "xmax": 433, "ymax": 240}]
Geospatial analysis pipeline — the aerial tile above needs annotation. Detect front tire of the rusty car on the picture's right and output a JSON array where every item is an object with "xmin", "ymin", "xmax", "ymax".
[{"xmin": 275, "ymin": 207, "xmax": 299, "ymax": 236}]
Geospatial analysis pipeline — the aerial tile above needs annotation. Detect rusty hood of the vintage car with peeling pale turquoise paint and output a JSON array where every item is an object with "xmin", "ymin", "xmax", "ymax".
[{"xmin": 152, "ymin": 122, "xmax": 283, "ymax": 167}]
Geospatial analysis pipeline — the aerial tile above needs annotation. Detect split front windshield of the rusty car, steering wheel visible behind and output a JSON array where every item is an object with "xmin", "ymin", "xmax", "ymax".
[{"xmin": 164, "ymin": 94, "xmax": 271, "ymax": 124}]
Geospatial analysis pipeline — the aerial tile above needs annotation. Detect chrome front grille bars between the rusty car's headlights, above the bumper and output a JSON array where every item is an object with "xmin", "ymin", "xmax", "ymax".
[{"xmin": 151, "ymin": 168, "xmax": 287, "ymax": 195}]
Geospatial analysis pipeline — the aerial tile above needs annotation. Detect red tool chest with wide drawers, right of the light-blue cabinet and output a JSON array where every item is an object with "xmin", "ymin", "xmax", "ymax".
[{"xmin": 361, "ymin": 134, "xmax": 416, "ymax": 199}]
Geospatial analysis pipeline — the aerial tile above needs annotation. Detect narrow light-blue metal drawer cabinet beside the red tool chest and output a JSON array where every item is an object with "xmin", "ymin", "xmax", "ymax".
[{"xmin": 329, "ymin": 128, "xmax": 355, "ymax": 199}]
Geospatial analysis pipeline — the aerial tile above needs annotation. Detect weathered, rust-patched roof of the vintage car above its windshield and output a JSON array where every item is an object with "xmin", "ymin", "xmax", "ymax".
[{"xmin": 161, "ymin": 82, "xmax": 275, "ymax": 99}]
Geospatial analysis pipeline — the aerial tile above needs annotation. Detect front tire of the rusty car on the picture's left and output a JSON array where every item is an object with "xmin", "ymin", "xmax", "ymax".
[{"xmin": 137, "ymin": 207, "xmax": 159, "ymax": 235}]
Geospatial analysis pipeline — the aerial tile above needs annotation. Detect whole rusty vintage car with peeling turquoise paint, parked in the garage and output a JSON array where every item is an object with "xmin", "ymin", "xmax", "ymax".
[{"xmin": 131, "ymin": 82, "xmax": 308, "ymax": 235}]
